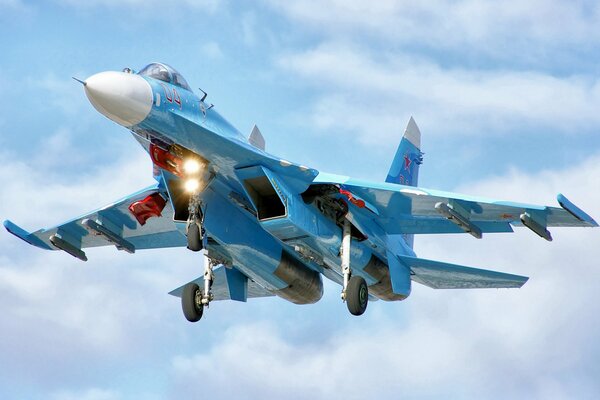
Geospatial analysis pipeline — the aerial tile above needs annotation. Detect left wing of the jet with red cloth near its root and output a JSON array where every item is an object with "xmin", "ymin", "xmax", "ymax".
[{"xmin": 4, "ymin": 184, "xmax": 187, "ymax": 261}]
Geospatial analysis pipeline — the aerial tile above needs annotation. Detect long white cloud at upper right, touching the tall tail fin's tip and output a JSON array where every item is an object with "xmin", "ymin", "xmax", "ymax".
[{"xmin": 278, "ymin": 43, "xmax": 600, "ymax": 144}]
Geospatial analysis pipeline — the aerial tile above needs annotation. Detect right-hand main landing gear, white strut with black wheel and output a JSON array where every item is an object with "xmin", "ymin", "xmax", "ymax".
[{"xmin": 340, "ymin": 219, "xmax": 369, "ymax": 315}]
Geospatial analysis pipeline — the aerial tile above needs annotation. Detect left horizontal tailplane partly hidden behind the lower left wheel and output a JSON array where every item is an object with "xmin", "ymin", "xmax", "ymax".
[{"xmin": 169, "ymin": 265, "xmax": 273, "ymax": 301}]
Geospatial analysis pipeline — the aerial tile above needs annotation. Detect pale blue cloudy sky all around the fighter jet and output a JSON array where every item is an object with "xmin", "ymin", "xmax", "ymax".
[{"xmin": 0, "ymin": 0, "xmax": 600, "ymax": 400}]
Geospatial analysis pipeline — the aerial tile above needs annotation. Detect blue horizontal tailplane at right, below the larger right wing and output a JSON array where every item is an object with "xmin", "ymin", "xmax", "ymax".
[{"xmin": 398, "ymin": 256, "xmax": 529, "ymax": 289}]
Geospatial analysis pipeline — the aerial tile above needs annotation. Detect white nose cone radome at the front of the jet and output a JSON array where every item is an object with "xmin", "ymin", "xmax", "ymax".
[{"xmin": 84, "ymin": 71, "xmax": 153, "ymax": 127}]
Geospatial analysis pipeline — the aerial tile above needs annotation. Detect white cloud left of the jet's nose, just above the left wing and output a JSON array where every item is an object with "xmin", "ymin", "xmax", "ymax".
[{"xmin": 0, "ymin": 138, "xmax": 155, "ymax": 228}]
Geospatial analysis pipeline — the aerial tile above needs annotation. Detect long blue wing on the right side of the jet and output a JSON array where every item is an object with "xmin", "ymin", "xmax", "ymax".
[{"xmin": 313, "ymin": 174, "xmax": 598, "ymax": 240}]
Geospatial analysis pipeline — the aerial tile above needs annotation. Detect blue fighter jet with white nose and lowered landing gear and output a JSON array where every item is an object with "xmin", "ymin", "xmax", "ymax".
[{"xmin": 4, "ymin": 63, "xmax": 597, "ymax": 322}]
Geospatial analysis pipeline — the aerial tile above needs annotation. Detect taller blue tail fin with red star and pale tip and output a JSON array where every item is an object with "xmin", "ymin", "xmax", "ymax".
[{"xmin": 385, "ymin": 117, "xmax": 423, "ymax": 186}]
